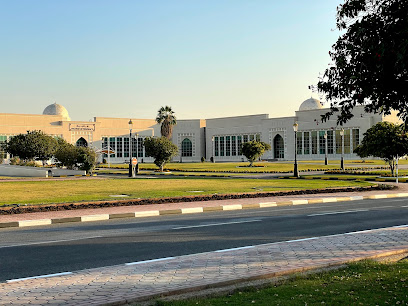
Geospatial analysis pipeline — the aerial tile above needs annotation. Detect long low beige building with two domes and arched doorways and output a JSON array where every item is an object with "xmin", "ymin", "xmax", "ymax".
[{"xmin": 0, "ymin": 98, "xmax": 399, "ymax": 163}]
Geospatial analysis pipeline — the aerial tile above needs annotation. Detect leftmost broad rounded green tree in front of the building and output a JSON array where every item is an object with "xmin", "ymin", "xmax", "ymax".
[{"xmin": 4, "ymin": 131, "xmax": 57, "ymax": 161}]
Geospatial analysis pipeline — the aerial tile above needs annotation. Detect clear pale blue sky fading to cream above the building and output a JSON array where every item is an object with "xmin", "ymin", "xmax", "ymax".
[{"xmin": 0, "ymin": 0, "xmax": 343, "ymax": 121}]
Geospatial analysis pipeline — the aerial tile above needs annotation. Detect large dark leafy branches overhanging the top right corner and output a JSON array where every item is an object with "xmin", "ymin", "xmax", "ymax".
[{"xmin": 318, "ymin": 0, "xmax": 408, "ymax": 124}]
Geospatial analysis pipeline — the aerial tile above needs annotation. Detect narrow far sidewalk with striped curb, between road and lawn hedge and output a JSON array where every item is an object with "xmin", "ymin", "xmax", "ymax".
[{"xmin": 0, "ymin": 184, "xmax": 408, "ymax": 228}]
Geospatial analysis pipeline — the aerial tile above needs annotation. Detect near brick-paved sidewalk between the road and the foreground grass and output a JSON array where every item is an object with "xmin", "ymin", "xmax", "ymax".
[{"xmin": 0, "ymin": 226, "xmax": 408, "ymax": 306}]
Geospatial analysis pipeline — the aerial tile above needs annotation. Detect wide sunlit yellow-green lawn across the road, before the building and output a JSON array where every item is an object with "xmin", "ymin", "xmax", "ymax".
[{"xmin": 0, "ymin": 178, "xmax": 371, "ymax": 205}]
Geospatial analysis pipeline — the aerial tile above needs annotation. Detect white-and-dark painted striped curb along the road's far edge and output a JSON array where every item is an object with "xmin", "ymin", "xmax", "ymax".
[{"xmin": 0, "ymin": 193, "xmax": 408, "ymax": 228}]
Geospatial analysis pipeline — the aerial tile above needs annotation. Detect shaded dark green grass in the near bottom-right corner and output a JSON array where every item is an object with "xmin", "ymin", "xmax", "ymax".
[{"xmin": 151, "ymin": 260, "xmax": 408, "ymax": 306}]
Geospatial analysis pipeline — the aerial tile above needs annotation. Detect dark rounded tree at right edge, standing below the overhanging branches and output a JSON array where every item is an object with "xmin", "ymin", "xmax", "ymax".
[{"xmin": 354, "ymin": 122, "xmax": 408, "ymax": 175}]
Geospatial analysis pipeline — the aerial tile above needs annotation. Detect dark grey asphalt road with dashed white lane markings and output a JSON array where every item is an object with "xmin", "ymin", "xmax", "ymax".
[{"xmin": 0, "ymin": 198, "xmax": 408, "ymax": 282}]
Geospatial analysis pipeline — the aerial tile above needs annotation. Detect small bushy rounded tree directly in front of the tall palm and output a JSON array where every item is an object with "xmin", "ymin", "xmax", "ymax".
[{"xmin": 143, "ymin": 136, "xmax": 178, "ymax": 172}]
